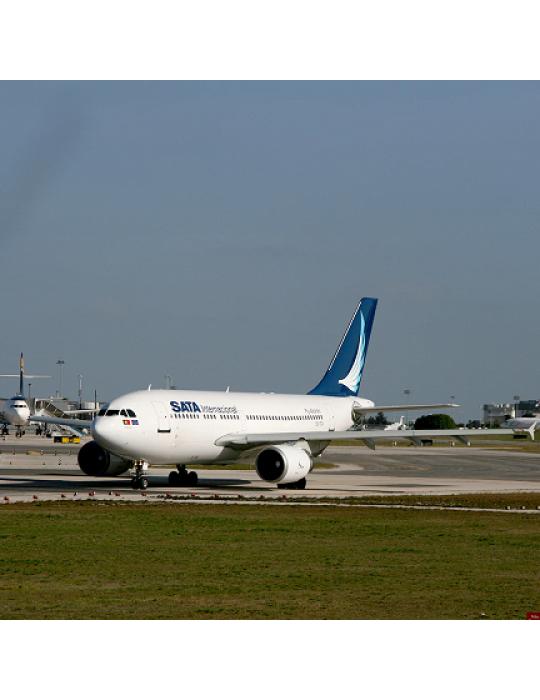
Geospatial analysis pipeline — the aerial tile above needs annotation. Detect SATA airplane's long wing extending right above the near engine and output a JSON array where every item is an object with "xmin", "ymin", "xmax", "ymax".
[{"xmin": 215, "ymin": 428, "xmax": 534, "ymax": 450}]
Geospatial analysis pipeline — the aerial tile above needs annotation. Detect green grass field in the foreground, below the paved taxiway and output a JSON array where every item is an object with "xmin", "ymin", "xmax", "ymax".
[{"xmin": 0, "ymin": 502, "xmax": 540, "ymax": 619}]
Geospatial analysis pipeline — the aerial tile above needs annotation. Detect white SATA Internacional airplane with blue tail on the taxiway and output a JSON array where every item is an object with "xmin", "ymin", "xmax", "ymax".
[{"xmin": 34, "ymin": 297, "xmax": 532, "ymax": 489}]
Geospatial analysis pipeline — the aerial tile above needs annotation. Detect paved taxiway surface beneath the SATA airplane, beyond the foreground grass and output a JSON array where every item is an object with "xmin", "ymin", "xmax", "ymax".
[{"xmin": 0, "ymin": 436, "xmax": 540, "ymax": 504}]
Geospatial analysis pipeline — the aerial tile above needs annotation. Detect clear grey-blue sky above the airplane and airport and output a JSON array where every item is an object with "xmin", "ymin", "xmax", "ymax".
[{"xmin": 0, "ymin": 82, "xmax": 540, "ymax": 418}]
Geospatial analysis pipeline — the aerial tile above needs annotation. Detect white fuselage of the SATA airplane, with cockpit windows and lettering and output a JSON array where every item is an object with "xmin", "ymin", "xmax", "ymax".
[{"xmin": 91, "ymin": 390, "xmax": 373, "ymax": 464}]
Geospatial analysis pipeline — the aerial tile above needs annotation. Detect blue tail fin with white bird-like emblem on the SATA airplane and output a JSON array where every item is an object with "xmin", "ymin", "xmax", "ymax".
[{"xmin": 309, "ymin": 297, "xmax": 377, "ymax": 396}]
